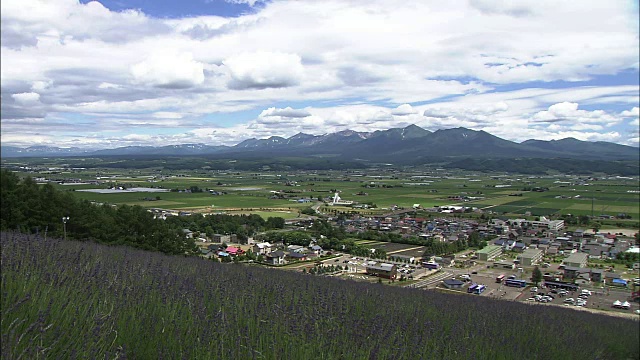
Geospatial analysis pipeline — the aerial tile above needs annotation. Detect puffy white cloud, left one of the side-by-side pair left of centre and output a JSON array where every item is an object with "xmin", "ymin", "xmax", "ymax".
[{"xmin": 131, "ymin": 52, "xmax": 204, "ymax": 89}]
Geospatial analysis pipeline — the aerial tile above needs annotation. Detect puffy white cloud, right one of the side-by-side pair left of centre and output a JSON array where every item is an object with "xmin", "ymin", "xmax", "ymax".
[{"xmin": 223, "ymin": 51, "xmax": 304, "ymax": 89}]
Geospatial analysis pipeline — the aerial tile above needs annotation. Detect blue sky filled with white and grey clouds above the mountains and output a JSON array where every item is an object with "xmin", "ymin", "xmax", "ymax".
[{"xmin": 0, "ymin": 0, "xmax": 640, "ymax": 149}]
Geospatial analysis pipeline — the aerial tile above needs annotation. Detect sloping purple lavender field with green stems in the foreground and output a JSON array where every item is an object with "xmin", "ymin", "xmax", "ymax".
[{"xmin": 1, "ymin": 232, "xmax": 640, "ymax": 360}]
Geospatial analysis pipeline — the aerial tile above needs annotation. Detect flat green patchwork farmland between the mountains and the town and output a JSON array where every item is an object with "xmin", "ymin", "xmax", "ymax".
[{"xmin": 5, "ymin": 159, "xmax": 640, "ymax": 222}]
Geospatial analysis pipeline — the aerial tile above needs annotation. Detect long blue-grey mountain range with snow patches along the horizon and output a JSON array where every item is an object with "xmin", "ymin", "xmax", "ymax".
[{"xmin": 0, "ymin": 125, "xmax": 640, "ymax": 163}]
